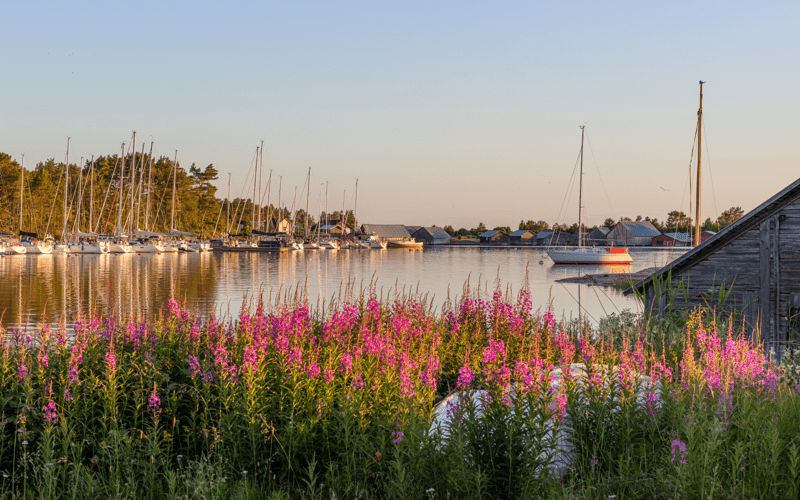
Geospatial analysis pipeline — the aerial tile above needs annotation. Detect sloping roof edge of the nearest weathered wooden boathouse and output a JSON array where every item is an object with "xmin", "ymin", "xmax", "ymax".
[{"xmin": 625, "ymin": 179, "xmax": 800, "ymax": 295}]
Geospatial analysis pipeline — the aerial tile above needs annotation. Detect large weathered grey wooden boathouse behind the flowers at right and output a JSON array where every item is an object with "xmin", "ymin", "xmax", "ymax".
[{"xmin": 625, "ymin": 179, "xmax": 800, "ymax": 358}]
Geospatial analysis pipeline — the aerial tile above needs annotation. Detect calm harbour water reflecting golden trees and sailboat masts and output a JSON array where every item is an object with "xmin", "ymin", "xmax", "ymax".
[{"xmin": 0, "ymin": 247, "xmax": 681, "ymax": 327}]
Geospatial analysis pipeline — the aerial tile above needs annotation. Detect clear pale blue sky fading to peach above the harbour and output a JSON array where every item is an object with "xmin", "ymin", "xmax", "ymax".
[{"xmin": 0, "ymin": 1, "xmax": 800, "ymax": 229}]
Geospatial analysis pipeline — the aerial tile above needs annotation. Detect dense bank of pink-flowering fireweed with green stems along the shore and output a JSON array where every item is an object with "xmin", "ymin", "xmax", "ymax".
[{"xmin": 0, "ymin": 290, "xmax": 800, "ymax": 499}]
